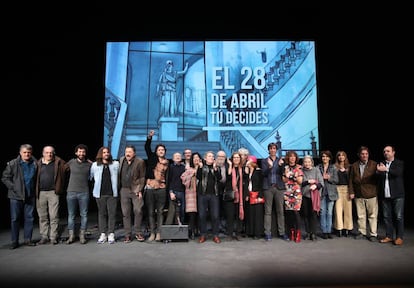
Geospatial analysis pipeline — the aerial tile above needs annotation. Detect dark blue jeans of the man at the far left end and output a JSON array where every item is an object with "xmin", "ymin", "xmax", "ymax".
[{"xmin": 10, "ymin": 197, "xmax": 36, "ymax": 243}]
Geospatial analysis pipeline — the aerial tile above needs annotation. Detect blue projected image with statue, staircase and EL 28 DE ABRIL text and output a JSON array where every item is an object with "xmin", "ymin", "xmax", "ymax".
[{"xmin": 104, "ymin": 41, "xmax": 319, "ymax": 158}]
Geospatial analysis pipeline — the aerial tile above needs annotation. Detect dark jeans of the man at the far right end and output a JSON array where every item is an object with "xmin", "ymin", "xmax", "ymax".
[{"xmin": 382, "ymin": 198, "xmax": 404, "ymax": 239}]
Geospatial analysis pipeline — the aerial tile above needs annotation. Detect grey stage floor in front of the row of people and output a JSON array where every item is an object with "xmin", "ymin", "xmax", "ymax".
[{"xmin": 0, "ymin": 219, "xmax": 414, "ymax": 288}]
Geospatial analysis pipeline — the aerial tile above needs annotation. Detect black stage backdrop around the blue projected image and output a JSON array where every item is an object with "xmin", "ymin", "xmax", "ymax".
[{"xmin": 0, "ymin": 9, "xmax": 414, "ymax": 227}]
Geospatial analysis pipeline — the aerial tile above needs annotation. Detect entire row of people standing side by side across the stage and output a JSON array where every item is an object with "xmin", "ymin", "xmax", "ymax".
[{"xmin": 2, "ymin": 137, "xmax": 405, "ymax": 249}]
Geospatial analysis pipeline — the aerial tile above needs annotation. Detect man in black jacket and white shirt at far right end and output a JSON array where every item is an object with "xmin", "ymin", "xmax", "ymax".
[{"xmin": 377, "ymin": 146, "xmax": 405, "ymax": 245}]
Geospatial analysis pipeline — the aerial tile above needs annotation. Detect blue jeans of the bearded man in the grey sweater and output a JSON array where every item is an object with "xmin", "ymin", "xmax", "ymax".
[{"xmin": 66, "ymin": 192, "xmax": 89, "ymax": 230}]
